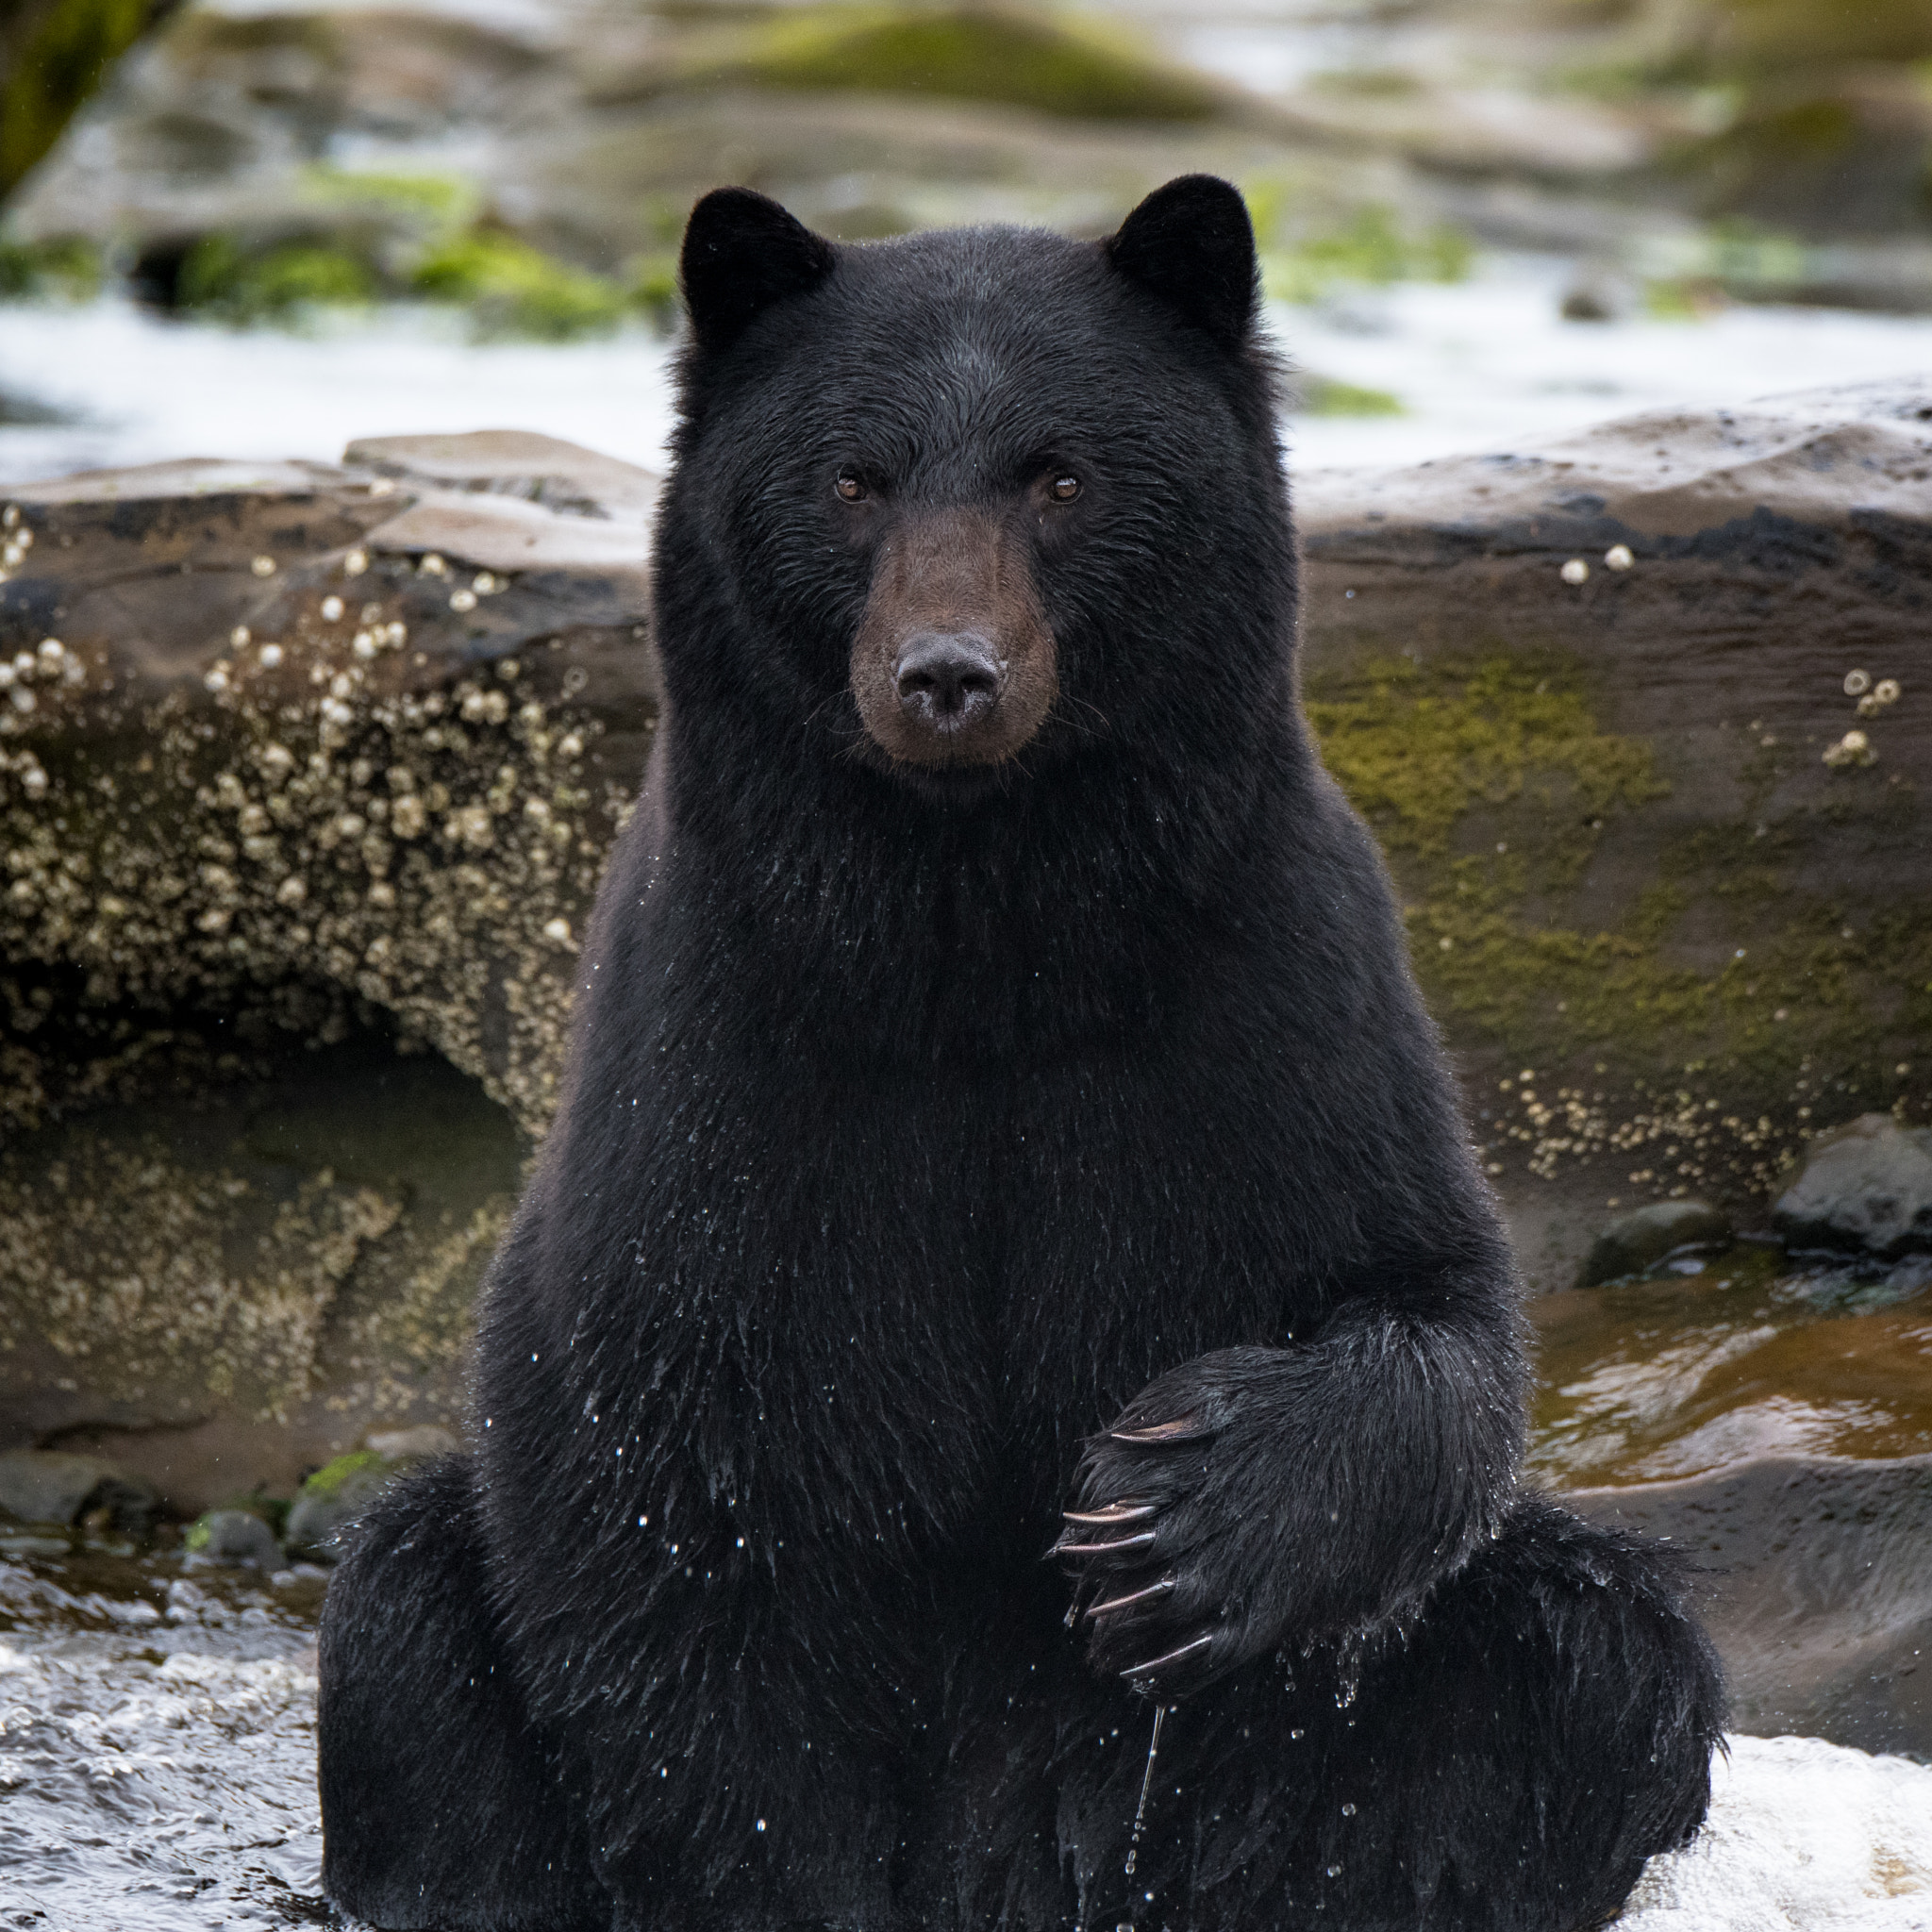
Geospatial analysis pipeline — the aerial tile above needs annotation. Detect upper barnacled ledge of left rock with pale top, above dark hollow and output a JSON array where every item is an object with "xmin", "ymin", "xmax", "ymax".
[{"xmin": 0, "ymin": 433, "xmax": 657, "ymax": 1132}]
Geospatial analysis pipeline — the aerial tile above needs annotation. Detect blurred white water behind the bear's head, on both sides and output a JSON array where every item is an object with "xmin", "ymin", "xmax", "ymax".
[{"xmin": 0, "ymin": 257, "xmax": 1932, "ymax": 485}]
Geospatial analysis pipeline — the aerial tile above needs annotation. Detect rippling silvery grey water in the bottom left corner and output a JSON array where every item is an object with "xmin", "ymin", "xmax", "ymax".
[{"xmin": 0, "ymin": 1552, "xmax": 328, "ymax": 1932}]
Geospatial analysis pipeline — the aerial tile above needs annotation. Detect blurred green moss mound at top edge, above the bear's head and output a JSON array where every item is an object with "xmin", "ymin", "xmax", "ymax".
[{"xmin": 718, "ymin": 6, "xmax": 1219, "ymax": 122}]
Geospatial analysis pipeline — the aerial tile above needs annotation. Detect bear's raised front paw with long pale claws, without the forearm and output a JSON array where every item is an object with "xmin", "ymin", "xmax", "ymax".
[{"xmin": 1053, "ymin": 1349, "xmax": 1287, "ymax": 1696}]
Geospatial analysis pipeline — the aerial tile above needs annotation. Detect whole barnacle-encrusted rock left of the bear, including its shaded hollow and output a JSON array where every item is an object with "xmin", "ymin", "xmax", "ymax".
[{"xmin": 0, "ymin": 435, "xmax": 657, "ymax": 1507}]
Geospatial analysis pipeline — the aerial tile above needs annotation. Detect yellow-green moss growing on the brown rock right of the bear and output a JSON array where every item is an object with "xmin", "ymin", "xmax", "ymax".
[{"xmin": 1307, "ymin": 653, "xmax": 1932, "ymax": 1180}]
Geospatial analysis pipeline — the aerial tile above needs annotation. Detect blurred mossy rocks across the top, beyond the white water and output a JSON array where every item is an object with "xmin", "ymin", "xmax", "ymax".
[{"xmin": 0, "ymin": 0, "xmax": 1932, "ymax": 351}]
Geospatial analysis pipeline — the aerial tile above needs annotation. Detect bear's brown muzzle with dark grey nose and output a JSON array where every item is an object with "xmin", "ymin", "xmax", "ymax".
[{"xmin": 852, "ymin": 510, "xmax": 1055, "ymax": 765}]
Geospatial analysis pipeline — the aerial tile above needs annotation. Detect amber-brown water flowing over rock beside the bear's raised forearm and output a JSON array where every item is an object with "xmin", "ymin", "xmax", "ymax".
[{"xmin": 1530, "ymin": 1244, "xmax": 1932, "ymax": 1486}]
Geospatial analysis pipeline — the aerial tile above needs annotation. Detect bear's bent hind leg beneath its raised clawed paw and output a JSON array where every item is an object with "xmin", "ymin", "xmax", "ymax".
[{"xmin": 1060, "ymin": 1495, "xmax": 1724, "ymax": 1932}]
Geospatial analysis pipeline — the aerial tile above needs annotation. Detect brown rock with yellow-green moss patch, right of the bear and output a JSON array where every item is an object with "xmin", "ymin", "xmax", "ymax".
[{"xmin": 1300, "ymin": 385, "xmax": 1932, "ymax": 1285}]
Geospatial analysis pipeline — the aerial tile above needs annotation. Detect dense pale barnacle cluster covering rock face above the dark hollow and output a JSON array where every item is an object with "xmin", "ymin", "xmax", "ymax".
[{"xmin": 0, "ymin": 521, "xmax": 641, "ymax": 1134}]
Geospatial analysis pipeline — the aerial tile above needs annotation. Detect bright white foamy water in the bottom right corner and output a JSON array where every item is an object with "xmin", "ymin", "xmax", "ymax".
[{"xmin": 1617, "ymin": 1737, "xmax": 1932, "ymax": 1932}]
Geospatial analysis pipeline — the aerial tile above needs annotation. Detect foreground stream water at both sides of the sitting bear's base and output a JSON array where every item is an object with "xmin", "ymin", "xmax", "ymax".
[{"xmin": 0, "ymin": 1522, "xmax": 1932, "ymax": 1932}]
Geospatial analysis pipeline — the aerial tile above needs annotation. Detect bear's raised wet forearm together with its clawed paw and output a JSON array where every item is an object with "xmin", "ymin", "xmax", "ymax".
[{"xmin": 1069, "ymin": 1298, "xmax": 1523, "ymax": 1672}]
